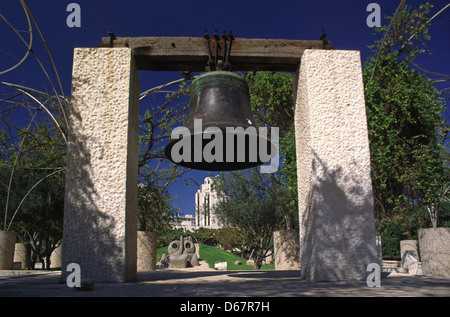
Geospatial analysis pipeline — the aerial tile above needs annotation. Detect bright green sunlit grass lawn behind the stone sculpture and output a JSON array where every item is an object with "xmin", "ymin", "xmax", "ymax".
[{"xmin": 156, "ymin": 244, "xmax": 275, "ymax": 270}]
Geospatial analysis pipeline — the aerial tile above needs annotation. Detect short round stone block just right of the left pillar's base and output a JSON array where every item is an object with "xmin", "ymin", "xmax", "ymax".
[{"xmin": 137, "ymin": 231, "xmax": 157, "ymax": 271}]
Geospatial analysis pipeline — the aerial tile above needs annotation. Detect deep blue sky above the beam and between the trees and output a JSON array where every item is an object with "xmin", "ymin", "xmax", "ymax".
[{"xmin": 0, "ymin": 0, "xmax": 450, "ymax": 213}]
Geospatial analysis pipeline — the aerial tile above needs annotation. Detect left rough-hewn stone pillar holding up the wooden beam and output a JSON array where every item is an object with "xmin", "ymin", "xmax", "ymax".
[{"xmin": 62, "ymin": 48, "xmax": 139, "ymax": 282}]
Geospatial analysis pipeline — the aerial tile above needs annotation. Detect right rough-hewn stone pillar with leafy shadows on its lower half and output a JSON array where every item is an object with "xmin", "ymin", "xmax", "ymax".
[{"xmin": 295, "ymin": 50, "xmax": 378, "ymax": 281}]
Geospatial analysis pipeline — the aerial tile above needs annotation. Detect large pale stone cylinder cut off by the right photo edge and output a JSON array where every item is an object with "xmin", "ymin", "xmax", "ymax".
[{"xmin": 419, "ymin": 228, "xmax": 450, "ymax": 278}]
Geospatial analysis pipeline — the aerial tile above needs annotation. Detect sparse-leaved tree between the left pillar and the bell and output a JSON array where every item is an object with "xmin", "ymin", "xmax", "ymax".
[{"xmin": 138, "ymin": 81, "xmax": 189, "ymax": 236}]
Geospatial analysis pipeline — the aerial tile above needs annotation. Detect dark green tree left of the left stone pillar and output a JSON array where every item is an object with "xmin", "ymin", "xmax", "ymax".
[{"xmin": 0, "ymin": 122, "xmax": 65, "ymax": 268}]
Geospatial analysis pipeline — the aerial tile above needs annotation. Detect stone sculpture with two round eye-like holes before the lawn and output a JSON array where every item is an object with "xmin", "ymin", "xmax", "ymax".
[{"xmin": 161, "ymin": 235, "xmax": 199, "ymax": 268}]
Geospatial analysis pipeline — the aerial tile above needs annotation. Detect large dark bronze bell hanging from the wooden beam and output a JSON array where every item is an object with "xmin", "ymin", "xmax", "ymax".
[{"xmin": 164, "ymin": 71, "xmax": 276, "ymax": 171}]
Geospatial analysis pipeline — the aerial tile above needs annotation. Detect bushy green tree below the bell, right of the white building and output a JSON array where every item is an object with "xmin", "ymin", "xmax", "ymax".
[{"xmin": 214, "ymin": 168, "xmax": 290, "ymax": 269}]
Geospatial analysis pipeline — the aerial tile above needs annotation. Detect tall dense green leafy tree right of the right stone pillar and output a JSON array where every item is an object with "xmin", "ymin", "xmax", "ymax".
[{"xmin": 363, "ymin": 4, "xmax": 448, "ymax": 222}]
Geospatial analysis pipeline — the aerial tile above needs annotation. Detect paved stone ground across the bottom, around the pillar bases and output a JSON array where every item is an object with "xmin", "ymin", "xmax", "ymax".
[{"xmin": 0, "ymin": 268, "xmax": 450, "ymax": 298}]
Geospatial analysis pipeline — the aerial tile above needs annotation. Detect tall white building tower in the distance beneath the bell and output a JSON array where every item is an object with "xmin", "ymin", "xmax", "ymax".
[{"xmin": 195, "ymin": 177, "xmax": 222, "ymax": 229}]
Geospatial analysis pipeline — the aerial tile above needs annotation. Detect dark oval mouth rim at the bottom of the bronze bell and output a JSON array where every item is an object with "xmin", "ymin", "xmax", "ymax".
[{"xmin": 164, "ymin": 129, "xmax": 277, "ymax": 172}]
